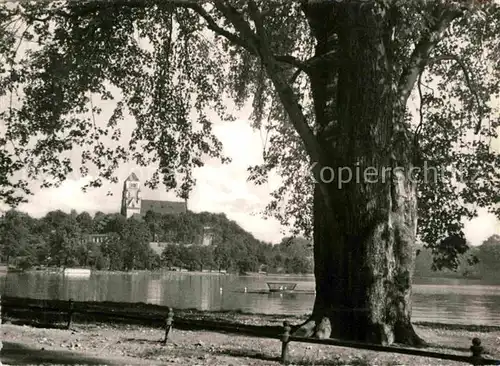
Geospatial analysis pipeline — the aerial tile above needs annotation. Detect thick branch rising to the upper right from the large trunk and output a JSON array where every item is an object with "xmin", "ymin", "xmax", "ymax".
[{"xmin": 398, "ymin": 5, "xmax": 463, "ymax": 105}]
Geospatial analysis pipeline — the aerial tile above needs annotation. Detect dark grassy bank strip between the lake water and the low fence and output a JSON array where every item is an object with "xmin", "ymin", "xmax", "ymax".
[{"xmin": 1, "ymin": 296, "xmax": 500, "ymax": 334}]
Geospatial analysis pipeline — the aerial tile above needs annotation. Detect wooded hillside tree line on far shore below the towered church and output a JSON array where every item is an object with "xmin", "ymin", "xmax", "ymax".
[{"xmin": 0, "ymin": 210, "xmax": 313, "ymax": 273}]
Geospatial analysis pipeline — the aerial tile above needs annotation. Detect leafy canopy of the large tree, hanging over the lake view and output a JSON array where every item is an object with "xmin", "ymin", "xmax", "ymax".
[{"xmin": 0, "ymin": 0, "xmax": 500, "ymax": 267}]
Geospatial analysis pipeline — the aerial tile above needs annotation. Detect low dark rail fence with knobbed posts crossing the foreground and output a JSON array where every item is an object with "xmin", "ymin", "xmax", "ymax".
[{"xmin": 0, "ymin": 297, "xmax": 500, "ymax": 365}]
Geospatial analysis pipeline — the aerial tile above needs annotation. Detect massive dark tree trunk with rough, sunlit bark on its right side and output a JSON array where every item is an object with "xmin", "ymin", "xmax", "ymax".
[{"xmin": 296, "ymin": 1, "xmax": 422, "ymax": 345}]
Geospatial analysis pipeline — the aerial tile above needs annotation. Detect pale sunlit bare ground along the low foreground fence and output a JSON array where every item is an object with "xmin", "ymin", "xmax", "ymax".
[{"xmin": 1, "ymin": 324, "xmax": 500, "ymax": 366}]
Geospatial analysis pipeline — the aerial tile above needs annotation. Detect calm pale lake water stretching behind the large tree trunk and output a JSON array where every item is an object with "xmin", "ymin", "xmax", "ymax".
[{"xmin": 0, "ymin": 272, "xmax": 500, "ymax": 326}]
